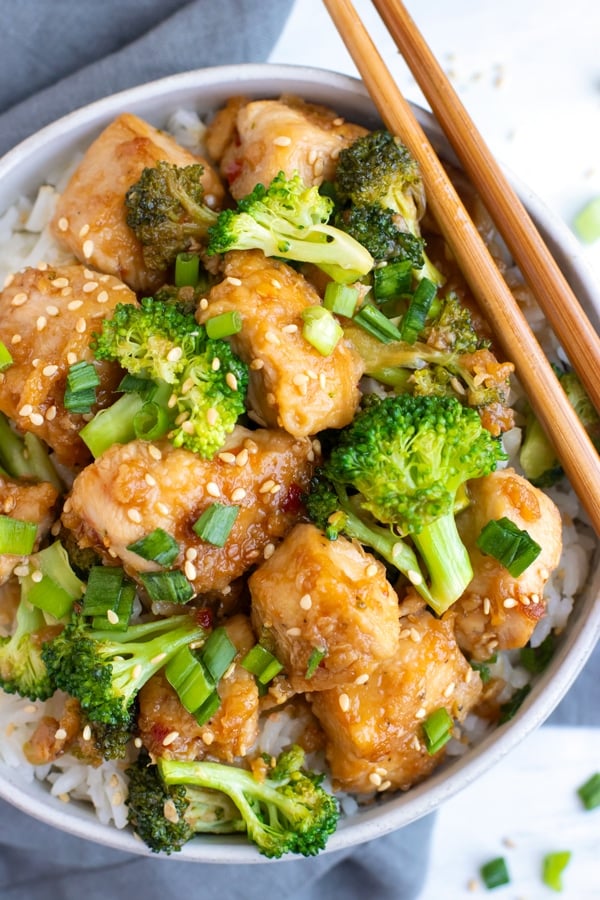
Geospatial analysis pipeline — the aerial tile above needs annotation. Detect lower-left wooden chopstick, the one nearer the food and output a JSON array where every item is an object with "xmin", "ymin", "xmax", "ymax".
[{"xmin": 324, "ymin": 0, "xmax": 600, "ymax": 535}]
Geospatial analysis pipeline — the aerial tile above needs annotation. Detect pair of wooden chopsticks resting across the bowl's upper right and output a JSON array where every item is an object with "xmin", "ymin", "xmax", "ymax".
[{"xmin": 323, "ymin": 0, "xmax": 600, "ymax": 535}]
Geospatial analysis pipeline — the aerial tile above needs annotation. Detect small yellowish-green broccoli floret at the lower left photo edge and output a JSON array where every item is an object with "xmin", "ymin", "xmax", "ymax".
[{"xmin": 0, "ymin": 598, "xmax": 54, "ymax": 700}]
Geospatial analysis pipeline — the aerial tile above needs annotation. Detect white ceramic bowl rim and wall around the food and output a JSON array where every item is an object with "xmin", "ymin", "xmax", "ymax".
[{"xmin": 0, "ymin": 65, "xmax": 600, "ymax": 863}]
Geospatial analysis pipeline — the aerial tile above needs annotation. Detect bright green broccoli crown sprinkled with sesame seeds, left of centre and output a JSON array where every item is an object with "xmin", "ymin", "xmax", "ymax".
[{"xmin": 89, "ymin": 297, "xmax": 248, "ymax": 458}]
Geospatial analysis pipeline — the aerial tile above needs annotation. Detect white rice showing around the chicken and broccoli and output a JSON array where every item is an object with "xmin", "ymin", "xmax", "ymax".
[{"xmin": 0, "ymin": 110, "xmax": 595, "ymax": 828}]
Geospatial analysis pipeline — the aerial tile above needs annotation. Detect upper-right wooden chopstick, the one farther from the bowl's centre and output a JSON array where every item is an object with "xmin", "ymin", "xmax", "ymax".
[{"xmin": 373, "ymin": 0, "xmax": 600, "ymax": 410}]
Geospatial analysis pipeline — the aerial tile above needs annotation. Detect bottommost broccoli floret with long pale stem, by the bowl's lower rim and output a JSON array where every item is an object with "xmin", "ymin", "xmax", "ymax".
[{"xmin": 127, "ymin": 746, "xmax": 339, "ymax": 858}]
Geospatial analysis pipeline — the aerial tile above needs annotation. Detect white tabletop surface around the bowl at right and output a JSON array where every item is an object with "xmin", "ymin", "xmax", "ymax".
[{"xmin": 271, "ymin": 0, "xmax": 600, "ymax": 900}]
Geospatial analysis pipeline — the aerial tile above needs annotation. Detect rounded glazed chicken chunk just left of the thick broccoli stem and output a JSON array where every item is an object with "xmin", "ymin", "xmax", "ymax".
[{"xmin": 249, "ymin": 524, "xmax": 400, "ymax": 691}]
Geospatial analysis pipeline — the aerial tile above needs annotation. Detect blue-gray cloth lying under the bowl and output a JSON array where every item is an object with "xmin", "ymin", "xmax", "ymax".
[{"xmin": 0, "ymin": 0, "xmax": 600, "ymax": 900}]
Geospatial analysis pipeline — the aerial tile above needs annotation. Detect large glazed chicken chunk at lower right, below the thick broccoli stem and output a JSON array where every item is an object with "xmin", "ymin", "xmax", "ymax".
[{"xmin": 309, "ymin": 610, "xmax": 481, "ymax": 793}]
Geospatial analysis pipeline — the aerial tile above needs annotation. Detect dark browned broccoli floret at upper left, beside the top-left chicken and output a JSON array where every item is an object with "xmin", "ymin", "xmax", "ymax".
[{"xmin": 125, "ymin": 160, "xmax": 218, "ymax": 271}]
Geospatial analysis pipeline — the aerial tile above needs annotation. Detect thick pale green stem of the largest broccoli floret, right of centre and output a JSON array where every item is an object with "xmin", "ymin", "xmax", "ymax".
[{"xmin": 411, "ymin": 511, "xmax": 473, "ymax": 615}]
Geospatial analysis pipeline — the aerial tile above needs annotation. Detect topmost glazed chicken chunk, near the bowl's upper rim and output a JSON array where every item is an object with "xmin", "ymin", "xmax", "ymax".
[{"xmin": 206, "ymin": 96, "xmax": 366, "ymax": 200}]
